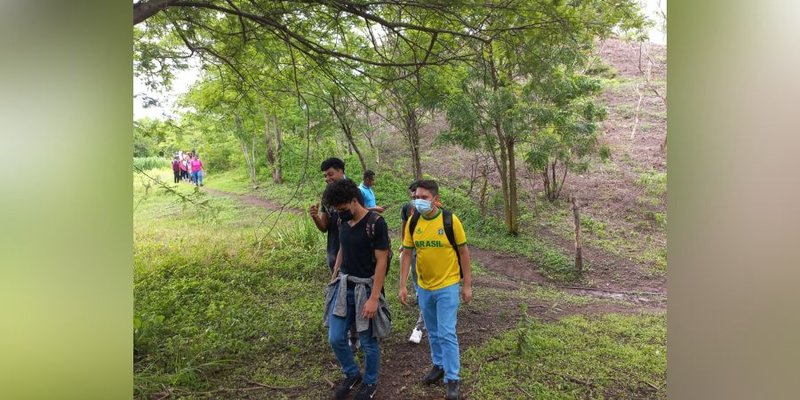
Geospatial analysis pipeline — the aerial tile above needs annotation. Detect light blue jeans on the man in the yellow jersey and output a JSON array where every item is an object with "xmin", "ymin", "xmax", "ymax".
[{"xmin": 417, "ymin": 283, "xmax": 461, "ymax": 382}]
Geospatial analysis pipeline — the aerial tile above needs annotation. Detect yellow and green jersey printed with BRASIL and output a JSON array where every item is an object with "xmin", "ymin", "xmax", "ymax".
[{"xmin": 403, "ymin": 210, "xmax": 467, "ymax": 290}]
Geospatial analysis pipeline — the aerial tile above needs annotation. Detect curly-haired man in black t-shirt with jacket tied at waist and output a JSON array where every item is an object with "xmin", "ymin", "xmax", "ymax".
[{"xmin": 322, "ymin": 179, "xmax": 391, "ymax": 400}]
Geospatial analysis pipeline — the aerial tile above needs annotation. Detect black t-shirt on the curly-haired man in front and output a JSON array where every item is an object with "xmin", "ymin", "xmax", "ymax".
[{"xmin": 339, "ymin": 211, "xmax": 391, "ymax": 278}]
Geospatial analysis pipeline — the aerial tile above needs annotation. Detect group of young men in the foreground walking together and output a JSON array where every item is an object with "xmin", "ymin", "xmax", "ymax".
[{"xmin": 309, "ymin": 158, "xmax": 472, "ymax": 400}]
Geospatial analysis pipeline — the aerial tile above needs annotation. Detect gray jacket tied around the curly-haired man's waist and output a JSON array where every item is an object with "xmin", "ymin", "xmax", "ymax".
[{"xmin": 323, "ymin": 274, "xmax": 392, "ymax": 338}]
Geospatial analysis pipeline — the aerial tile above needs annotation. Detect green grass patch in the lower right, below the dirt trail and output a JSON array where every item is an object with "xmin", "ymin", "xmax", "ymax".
[{"xmin": 462, "ymin": 314, "xmax": 667, "ymax": 399}]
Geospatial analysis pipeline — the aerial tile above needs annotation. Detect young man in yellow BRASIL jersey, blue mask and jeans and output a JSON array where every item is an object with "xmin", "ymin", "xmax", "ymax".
[{"xmin": 399, "ymin": 180, "xmax": 472, "ymax": 400}]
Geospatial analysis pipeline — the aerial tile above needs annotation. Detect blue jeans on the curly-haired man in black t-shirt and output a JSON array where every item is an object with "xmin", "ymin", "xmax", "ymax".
[{"xmin": 328, "ymin": 283, "xmax": 381, "ymax": 384}]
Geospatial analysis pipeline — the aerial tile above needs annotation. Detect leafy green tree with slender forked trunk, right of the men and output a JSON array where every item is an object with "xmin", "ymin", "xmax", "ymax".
[{"xmin": 444, "ymin": 0, "xmax": 642, "ymax": 234}]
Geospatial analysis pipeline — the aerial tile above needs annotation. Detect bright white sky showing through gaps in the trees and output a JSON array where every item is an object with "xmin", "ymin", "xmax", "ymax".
[{"xmin": 133, "ymin": 0, "xmax": 667, "ymax": 120}]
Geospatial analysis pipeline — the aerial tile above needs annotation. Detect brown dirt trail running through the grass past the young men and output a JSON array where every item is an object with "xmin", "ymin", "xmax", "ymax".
[{"xmin": 204, "ymin": 188, "xmax": 666, "ymax": 399}]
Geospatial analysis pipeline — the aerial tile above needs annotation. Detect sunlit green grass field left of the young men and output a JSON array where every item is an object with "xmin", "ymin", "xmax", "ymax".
[{"xmin": 133, "ymin": 170, "xmax": 424, "ymax": 398}]
